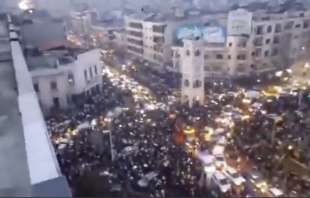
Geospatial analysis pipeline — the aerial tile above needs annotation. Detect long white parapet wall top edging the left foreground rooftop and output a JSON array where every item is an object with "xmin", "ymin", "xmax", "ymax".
[{"xmin": 10, "ymin": 21, "xmax": 63, "ymax": 187}]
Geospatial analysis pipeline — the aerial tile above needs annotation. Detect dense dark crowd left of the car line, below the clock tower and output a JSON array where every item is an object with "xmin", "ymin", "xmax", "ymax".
[{"xmin": 47, "ymin": 70, "xmax": 213, "ymax": 197}]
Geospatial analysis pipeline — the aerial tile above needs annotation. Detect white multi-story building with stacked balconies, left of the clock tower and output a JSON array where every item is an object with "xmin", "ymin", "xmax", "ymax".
[{"xmin": 125, "ymin": 8, "xmax": 225, "ymax": 69}]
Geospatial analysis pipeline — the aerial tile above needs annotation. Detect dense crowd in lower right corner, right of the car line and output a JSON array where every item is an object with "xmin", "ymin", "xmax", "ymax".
[{"xmin": 233, "ymin": 90, "xmax": 310, "ymax": 197}]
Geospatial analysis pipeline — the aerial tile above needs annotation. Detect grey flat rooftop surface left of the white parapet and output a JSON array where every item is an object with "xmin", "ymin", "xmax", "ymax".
[{"xmin": 0, "ymin": 21, "xmax": 31, "ymax": 197}]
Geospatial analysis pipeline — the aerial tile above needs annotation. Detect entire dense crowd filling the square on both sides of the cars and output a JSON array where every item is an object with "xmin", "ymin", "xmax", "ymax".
[{"xmin": 47, "ymin": 56, "xmax": 310, "ymax": 197}]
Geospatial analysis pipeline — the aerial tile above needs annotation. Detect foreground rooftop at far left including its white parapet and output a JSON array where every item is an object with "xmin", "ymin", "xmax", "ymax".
[{"xmin": 0, "ymin": 15, "xmax": 71, "ymax": 197}]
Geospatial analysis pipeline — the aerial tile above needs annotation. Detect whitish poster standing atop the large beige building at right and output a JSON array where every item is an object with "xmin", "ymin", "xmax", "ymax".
[{"xmin": 227, "ymin": 9, "xmax": 253, "ymax": 35}]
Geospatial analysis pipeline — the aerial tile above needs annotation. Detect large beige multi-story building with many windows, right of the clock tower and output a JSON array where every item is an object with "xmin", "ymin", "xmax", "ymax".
[{"xmin": 173, "ymin": 9, "xmax": 310, "ymax": 78}]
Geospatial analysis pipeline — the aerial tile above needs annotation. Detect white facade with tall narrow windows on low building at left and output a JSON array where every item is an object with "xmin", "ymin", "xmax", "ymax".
[{"xmin": 28, "ymin": 49, "xmax": 103, "ymax": 112}]
